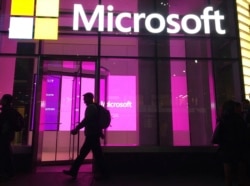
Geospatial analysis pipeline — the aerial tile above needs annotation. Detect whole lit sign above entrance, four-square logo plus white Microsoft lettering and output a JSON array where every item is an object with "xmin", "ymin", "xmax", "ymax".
[{"xmin": 9, "ymin": 0, "xmax": 226, "ymax": 40}]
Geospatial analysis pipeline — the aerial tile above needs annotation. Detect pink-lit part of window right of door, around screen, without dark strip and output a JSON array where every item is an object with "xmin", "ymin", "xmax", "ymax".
[{"xmin": 101, "ymin": 59, "xmax": 139, "ymax": 146}]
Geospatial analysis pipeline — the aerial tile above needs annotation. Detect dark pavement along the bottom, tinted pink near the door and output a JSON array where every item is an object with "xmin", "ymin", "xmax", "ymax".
[{"xmin": 0, "ymin": 165, "xmax": 227, "ymax": 186}]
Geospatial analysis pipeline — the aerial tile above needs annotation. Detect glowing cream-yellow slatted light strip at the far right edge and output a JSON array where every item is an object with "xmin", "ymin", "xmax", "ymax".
[{"xmin": 236, "ymin": 0, "xmax": 250, "ymax": 99}]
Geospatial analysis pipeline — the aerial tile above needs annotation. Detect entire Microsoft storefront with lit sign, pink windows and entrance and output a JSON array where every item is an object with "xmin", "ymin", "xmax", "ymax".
[{"xmin": 0, "ymin": 0, "xmax": 250, "ymax": 161}]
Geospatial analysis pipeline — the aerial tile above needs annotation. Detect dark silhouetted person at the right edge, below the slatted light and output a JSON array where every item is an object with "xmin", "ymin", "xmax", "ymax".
[{"xmin": 213, "ymin": 100, "xmax": 248, "ymax": 186}]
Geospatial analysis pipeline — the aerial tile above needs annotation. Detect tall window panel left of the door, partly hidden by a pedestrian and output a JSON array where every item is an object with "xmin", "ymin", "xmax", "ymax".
[{"xmin": 0, "ymin": 56, "xmax": 37, "ymax": 145}]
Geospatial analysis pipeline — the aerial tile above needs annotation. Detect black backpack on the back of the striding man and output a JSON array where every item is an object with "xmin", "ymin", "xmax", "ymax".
[{"xmin": 96, "ymin": 104, "xmax": 111, "ymax": 129}]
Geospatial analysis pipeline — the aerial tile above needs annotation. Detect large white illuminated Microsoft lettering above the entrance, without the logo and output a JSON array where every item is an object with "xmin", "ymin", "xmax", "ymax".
[{"xmin": 73, "ymin": 4, "xmax": 226, "ymax": 35}]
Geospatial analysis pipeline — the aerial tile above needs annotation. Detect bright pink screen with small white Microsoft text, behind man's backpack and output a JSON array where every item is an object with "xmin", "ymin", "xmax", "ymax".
[{"xmin": 101, "ymin": 76, "xmax": 136, "ymax": 131}]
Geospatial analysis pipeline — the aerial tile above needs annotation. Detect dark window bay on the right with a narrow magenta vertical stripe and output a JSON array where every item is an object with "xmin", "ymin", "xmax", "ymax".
[{"xmin": 158, "ymin": 60, "xmax": 216, "ymax": 146}]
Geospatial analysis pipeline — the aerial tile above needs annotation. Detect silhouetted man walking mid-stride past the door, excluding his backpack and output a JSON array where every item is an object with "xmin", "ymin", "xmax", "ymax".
[{"xmin": 63, "ymin": 92, "xmax": 107, "ymax": 179}]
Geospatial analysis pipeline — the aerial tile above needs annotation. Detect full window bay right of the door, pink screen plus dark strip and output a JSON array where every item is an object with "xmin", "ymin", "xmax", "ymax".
[{"xmin": 101, "ymin": 58, "xmax": 157, "ymax": 146}]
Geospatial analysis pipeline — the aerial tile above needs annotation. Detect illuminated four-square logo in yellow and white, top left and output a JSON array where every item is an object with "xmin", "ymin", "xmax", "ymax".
[{"xmin": 9, "ymin": 0, "xmax": 60, "ymax": 40}]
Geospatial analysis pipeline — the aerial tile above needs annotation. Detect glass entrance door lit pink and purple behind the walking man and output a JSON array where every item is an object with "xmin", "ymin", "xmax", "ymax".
[{"xmin": 39, "ymin": 60, "xmax": 108, "ymax": 162}]
